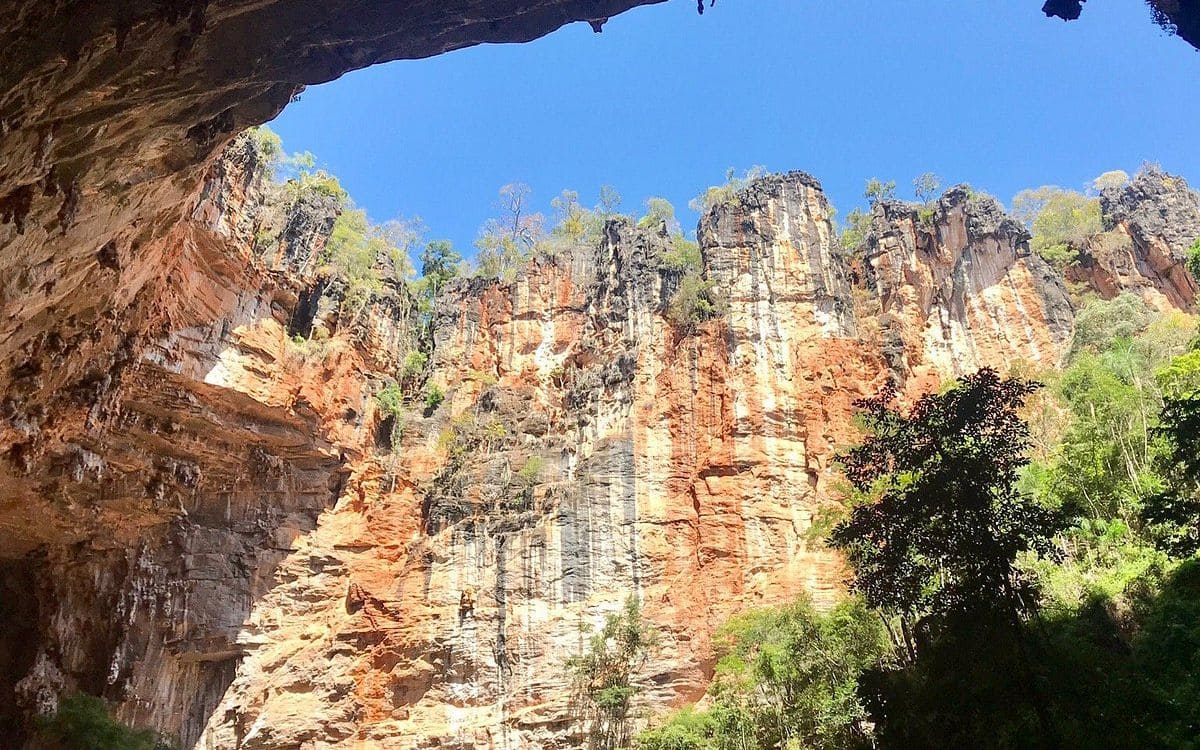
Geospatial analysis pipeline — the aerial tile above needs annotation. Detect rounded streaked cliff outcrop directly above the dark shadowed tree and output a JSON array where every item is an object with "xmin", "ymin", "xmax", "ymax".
[{"xmin": 862, "ymin": 186, "xmax": 1074, "ymax": 392}]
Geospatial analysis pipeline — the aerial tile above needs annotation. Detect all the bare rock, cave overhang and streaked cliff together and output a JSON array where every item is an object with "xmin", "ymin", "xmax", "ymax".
[{"xmin": 0, "ymin": 0, "xmax": 1200, "ymax": 748}]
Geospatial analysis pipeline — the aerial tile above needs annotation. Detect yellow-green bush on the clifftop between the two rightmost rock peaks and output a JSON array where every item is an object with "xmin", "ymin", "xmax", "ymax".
[{"xmin": 1013, "ymin": 186, "xmax": 1104, "ymax": 268}]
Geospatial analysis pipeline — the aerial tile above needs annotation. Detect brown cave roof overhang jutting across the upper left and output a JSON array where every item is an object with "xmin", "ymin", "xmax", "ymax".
[{"xmin": 0, "ymin": 0, "xmax": 647, "ymax": 554}]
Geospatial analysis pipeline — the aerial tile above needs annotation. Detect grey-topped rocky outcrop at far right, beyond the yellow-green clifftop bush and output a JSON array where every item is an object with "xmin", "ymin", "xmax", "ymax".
[{"xmin": 1067, "ymin": 167, "xmax": 1200, "ymax": 311}]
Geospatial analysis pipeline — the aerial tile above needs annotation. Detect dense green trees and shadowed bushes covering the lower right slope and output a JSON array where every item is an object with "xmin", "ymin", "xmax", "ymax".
[{"xmin": 635, "ymin": 295, "xmax": 1200, "ymax": 750}]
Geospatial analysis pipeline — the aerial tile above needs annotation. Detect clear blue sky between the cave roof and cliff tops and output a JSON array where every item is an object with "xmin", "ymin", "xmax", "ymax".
[{"xmin": 271, "ymin": 0, "xmax": 1200, "ymax": 254}]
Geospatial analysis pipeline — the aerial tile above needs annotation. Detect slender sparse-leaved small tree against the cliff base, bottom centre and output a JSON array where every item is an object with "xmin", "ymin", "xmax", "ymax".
[{"xmin": 566, "ymin": 596, "xmax": 659, "ymax": 750}]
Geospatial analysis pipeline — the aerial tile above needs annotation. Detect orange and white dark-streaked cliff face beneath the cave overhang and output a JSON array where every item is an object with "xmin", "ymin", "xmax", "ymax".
[{"xmin": 0, "ymin": 148, "xmax": 1195, "ymax": 750}]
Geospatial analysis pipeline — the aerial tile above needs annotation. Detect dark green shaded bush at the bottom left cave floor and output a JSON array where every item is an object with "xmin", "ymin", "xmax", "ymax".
[{"xmin": 34, "ymin": 692, "xmax": 172, "ymax": 750}]
